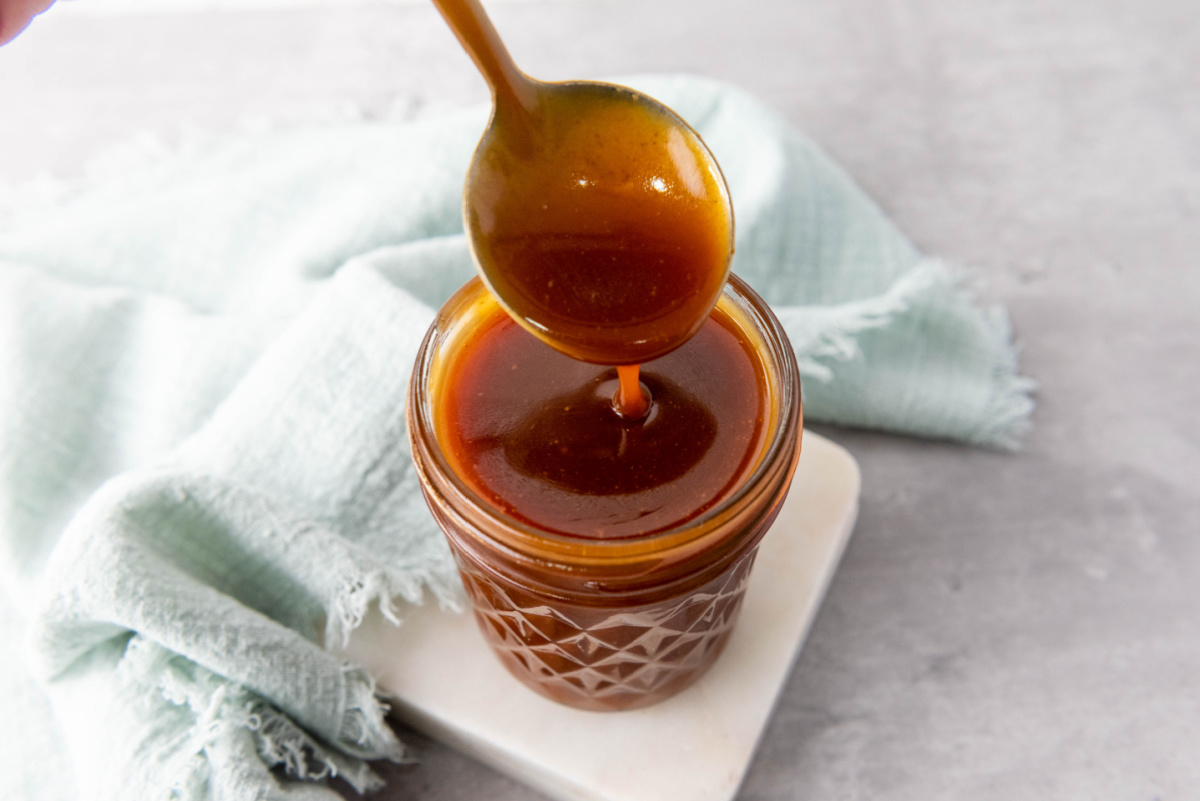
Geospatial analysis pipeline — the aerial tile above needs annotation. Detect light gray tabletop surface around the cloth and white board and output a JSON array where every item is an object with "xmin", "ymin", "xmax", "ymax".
[{"xmin": 0, "ymin": 0, "xmax": 1200, "ymax": 801}]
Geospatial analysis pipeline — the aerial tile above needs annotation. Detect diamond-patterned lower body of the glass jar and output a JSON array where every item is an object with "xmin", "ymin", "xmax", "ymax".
[{"xmin": 458, "ymin": 550, "xmax": 754, "ymax": 710}]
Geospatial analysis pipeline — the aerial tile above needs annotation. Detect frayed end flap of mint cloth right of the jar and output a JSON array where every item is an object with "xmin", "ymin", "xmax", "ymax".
[{"xmin": 776, "ymin": 259, "xmax": 1037, "ymax": 450}]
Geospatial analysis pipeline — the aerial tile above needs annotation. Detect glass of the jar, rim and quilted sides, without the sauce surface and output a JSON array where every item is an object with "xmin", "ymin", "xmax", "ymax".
[{"xmin": 407, "ymin": 276, "xmax": 803, "ymax": 711}]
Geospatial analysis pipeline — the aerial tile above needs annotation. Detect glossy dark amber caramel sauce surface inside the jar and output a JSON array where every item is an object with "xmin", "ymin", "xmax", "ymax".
[{"xmin": 434, "ymin": 298, "xmax": 770, "ymax": 540}]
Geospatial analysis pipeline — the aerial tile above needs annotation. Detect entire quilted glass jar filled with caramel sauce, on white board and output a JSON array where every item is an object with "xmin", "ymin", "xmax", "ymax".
[{"xmin": 407, "ymin": 276, "xmax": 803, "ymax": 711}]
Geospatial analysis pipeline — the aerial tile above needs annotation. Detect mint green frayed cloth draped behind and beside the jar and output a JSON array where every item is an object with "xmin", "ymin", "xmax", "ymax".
[{"xmin": 0, "ymin": 78, "xmax": 1031, "ymax": 799}]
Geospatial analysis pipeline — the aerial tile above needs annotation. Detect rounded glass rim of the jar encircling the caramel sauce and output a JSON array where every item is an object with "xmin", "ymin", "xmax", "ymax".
[{"xmin": 407, "ymin": 272, "xmax": 803, "ymax": 565}]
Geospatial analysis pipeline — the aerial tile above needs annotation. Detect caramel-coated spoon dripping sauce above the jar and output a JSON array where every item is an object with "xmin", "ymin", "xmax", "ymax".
[{"xmin": 433, "ymin": 0, "xmax": 733, "ymax": 378}]
